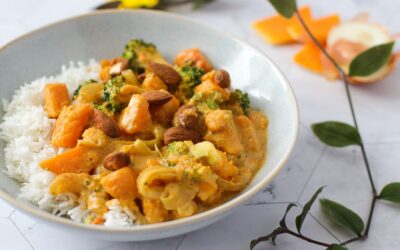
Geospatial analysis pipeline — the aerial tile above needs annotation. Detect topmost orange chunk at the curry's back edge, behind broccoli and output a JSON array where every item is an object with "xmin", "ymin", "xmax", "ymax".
[{"xmin": 175, "ymin": 48, "xmax": 213, "ymax": 72}]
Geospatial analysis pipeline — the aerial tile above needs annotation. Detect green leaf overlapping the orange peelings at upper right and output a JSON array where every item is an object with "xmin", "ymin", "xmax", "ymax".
[{"xmin": 349, "ymin": 42, "xmax": 394, "ymax": 76}]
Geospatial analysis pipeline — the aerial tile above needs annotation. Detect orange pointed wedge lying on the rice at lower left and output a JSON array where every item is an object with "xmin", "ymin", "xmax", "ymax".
[{"xmin": 40, "ymin": 147, "xmax": 101, "ymax": 175}]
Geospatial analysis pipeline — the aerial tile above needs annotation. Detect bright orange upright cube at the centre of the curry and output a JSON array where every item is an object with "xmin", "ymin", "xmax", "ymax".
[{"xmin": 119, "ymin": 94, "xmax": 152, "ymax": 134}]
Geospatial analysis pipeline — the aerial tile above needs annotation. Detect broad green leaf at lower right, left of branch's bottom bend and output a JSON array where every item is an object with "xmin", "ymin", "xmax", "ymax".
[{"xmin": 319, "ymin": 199, "xmax": 364, "ymax": 236}]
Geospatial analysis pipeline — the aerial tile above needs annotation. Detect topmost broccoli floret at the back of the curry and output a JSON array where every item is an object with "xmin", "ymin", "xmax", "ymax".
[{"xmin": 122, "ymin": 39, "xmax": 161, "ymax": 74}]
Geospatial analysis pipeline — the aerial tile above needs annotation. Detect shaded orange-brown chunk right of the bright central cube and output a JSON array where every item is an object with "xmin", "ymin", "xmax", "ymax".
[{"xmin": 150, "ymin": 96, "xmax": 179, "ymax": 127}]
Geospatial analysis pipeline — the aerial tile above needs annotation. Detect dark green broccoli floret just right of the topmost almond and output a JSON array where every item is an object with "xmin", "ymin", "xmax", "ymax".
[{"xmin": 176, "ymin": 64, "xmax": 205, "ymax": 101}]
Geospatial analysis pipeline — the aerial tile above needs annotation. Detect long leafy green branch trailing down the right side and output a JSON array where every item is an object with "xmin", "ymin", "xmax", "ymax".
[{"xmin": 250, "ymin": 0, "xmax": 400, "ymax": 250}]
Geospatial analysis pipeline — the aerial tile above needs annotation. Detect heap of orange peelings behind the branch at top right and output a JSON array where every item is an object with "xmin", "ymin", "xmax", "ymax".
[{"xmin": 253, "ymin": 6, "xmax": 400, "ymax": 84}]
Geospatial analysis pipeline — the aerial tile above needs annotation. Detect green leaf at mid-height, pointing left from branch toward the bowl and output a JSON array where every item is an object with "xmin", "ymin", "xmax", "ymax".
[{"xmin": 311, "ymin": 121, "xmax": 361, "ymax": 147}]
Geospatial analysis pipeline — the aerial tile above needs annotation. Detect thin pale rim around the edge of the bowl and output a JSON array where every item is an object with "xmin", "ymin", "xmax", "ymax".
[{"xmin": 0, "ymin": 9, "xmax": 299, "ymax": 234}]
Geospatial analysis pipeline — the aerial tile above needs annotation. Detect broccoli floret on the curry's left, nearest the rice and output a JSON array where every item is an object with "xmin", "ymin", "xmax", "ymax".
[{"xmin": 95, "ymin": 76, "xmax": 125, "ymax": 114}]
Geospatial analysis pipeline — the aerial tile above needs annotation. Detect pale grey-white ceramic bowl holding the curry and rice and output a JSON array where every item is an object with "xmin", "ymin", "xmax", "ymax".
[{"xmin": 0, "ymin": 10, "xmax": 298, "ymax": 241}]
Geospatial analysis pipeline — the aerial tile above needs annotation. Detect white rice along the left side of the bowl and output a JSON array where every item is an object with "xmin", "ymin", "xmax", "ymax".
[{"xmin": 0, "ymin": 60, "xmax": 134, "ymax": 226}]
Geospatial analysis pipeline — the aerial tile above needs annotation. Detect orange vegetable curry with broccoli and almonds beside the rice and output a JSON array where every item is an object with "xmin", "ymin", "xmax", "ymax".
[{"xmin": 40, "ymin": 40, "xmax": 268, "ymax": 224}]
